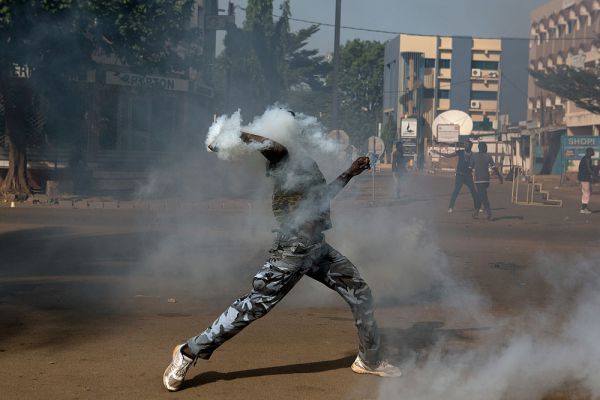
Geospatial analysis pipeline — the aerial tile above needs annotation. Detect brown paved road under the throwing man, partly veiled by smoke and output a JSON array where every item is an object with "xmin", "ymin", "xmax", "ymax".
[{"xmin": 0, "ymin": 176, "xmax": 600, "ymax": 400}]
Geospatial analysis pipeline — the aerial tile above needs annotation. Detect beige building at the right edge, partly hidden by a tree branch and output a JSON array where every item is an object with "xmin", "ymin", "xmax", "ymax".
[{"xmin": 528, "ymin": 0, "xmax": 600, "ymax": 159}]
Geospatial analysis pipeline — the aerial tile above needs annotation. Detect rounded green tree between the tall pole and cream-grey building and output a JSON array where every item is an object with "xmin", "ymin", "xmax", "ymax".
[{"xmin": 339, "ymin": 39, "xmax": 384, "ymax": 146}]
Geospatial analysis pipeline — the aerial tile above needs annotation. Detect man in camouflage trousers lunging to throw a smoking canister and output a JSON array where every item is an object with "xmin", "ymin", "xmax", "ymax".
[{"xmin": 163, "ymin": 122, "xmax": 401, "ymax": 391}]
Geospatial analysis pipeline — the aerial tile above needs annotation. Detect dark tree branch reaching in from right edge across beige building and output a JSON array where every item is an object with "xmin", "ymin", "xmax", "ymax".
[{"xmin": 529, "ymin": 65, "xmax": 600, "ymax": 114}]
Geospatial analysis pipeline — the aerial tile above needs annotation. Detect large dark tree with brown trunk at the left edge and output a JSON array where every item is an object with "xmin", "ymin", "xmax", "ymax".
[{"xmin": 0, "ymin": 0, "xmax": 194, "ymax": 200}]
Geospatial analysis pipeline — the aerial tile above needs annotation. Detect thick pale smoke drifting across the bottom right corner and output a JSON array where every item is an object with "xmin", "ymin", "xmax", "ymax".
[{"xmin": 379, "ymin": 250, "xmax": 600, "ymax": 400}]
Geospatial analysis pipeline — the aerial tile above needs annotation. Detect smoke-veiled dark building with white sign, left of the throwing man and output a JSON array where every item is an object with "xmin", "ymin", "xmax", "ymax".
[{"xmin": 0, "ymin": 0, "xmax": 227, "ymax": 191}]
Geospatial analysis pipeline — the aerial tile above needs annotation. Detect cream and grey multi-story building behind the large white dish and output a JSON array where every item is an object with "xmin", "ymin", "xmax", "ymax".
[{"xmin": 383, "ymin": 34, "xmax": 527, "ymax": 163}]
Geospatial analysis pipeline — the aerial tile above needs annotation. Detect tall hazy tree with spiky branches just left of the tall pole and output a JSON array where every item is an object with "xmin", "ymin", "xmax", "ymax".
[{"xmin": 219, "ymin": 0, "xmax": 328, "ymax": 115}]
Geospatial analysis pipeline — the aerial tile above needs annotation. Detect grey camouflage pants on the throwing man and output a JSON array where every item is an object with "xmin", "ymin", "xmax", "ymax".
[{"xmin": 187, "ymin": 234, "xmax": 380, "ymax": 365}]
